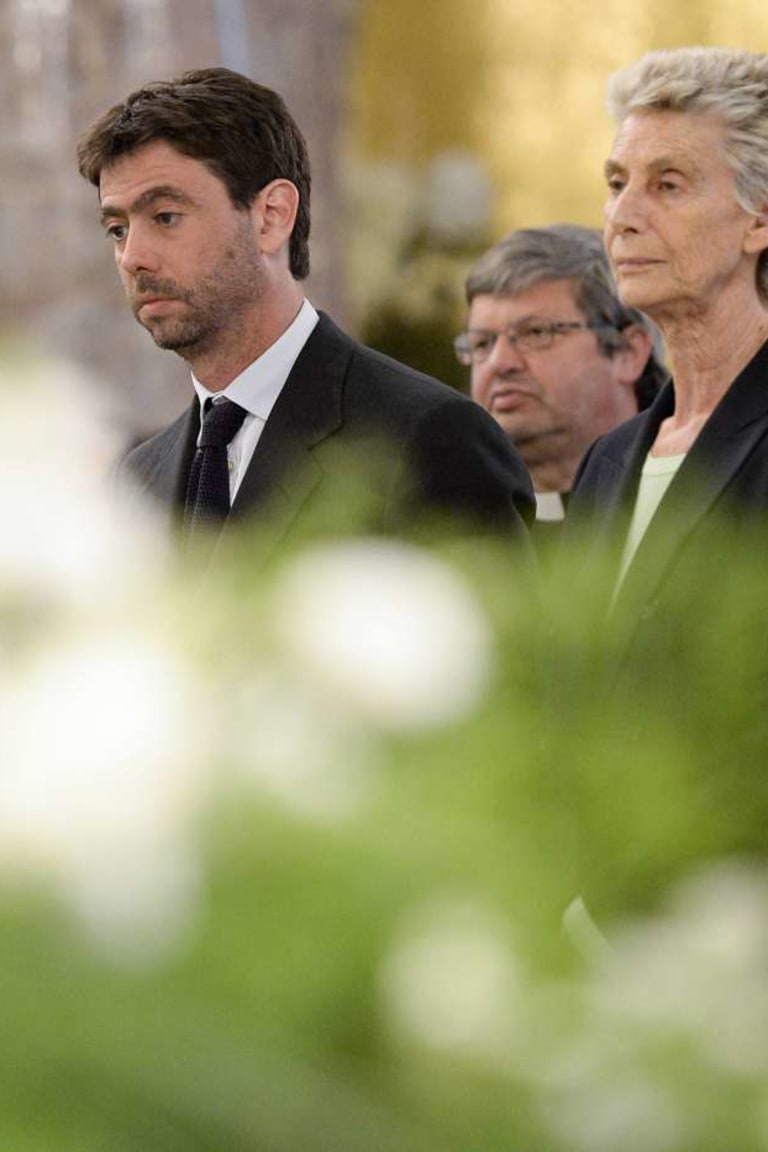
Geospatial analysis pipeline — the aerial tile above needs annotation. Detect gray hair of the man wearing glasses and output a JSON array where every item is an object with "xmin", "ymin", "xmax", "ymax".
[{"xmin": 465, "ymin": 223, "xmax": 669, "ymax": 409}]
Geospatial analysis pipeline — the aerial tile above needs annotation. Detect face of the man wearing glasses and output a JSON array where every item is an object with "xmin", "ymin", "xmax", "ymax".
[{"xmin": 467, "ymin": 280, "xmax": 625, "ymax": 455}]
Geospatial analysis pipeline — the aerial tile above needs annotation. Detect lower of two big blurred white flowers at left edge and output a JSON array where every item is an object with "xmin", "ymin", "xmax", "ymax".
[{"xmin": 0, "ymin": 634, "xmax": 208, "ymax": 958}]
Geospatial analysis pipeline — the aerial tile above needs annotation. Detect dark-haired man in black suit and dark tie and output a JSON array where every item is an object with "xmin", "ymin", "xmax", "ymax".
[{"xmin": 78, "ymin": 68, "xmax": 533, "ymax": 562}]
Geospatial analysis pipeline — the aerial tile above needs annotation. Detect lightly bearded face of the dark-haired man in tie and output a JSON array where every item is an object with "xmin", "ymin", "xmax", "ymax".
[{"xmin": 99, "ymin": 141, "xmax": 263, "ymax": 358}]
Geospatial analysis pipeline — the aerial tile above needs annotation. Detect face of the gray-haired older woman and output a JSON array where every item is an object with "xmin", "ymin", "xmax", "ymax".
[{"xmin": 604, "ymin": 109, "xmax": 768, "ymax": 319}]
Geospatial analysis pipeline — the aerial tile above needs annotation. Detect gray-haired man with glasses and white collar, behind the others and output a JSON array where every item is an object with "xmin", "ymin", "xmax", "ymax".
[{"xmin": 455, "ymin": 225, "xmax": 666, "ymax": 521}]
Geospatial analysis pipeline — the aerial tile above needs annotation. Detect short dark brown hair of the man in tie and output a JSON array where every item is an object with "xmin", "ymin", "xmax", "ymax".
[{"xmin": 77, "ymin": 68, "xmax": 311, "ymax": 280}]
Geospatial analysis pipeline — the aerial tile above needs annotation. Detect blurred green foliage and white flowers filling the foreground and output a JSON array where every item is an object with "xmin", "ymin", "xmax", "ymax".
[{"xmin": 0, "ymin": 353, "xmax": 768, "ymax": 1152}]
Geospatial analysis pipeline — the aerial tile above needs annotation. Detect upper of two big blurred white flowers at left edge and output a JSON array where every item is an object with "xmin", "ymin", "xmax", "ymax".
[{"xmin": 0, "ymin": 358, "xmax": 167, "ymax": 606}]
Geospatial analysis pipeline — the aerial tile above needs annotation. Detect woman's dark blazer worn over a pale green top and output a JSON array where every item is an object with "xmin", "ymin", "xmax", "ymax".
[{"xmin": 565, "ymin": 343, "xmax": 768, "ymax": 643}]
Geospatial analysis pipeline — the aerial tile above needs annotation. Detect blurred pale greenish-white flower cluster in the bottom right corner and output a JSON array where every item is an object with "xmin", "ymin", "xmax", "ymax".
[{"xmin": 530, "ymin": 862, "xmax": 768, "ymax": 1152}]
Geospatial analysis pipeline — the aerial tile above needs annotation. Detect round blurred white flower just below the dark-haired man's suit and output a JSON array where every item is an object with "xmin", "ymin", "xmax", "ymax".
[{"xmin": 273, "ymin": 539, "xmax": 492, "ymax": 728}]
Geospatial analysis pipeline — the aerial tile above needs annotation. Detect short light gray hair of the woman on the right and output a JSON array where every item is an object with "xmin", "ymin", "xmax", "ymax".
[{"xmin": 608, "ymin": 47, "xmax": 768, "ymax": 301}]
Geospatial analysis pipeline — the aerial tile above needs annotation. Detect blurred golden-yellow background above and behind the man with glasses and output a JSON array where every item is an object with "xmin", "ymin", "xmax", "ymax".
[{"xmin": 344, "ymin": 0, "xmax": 768, "ymax": 387}]
